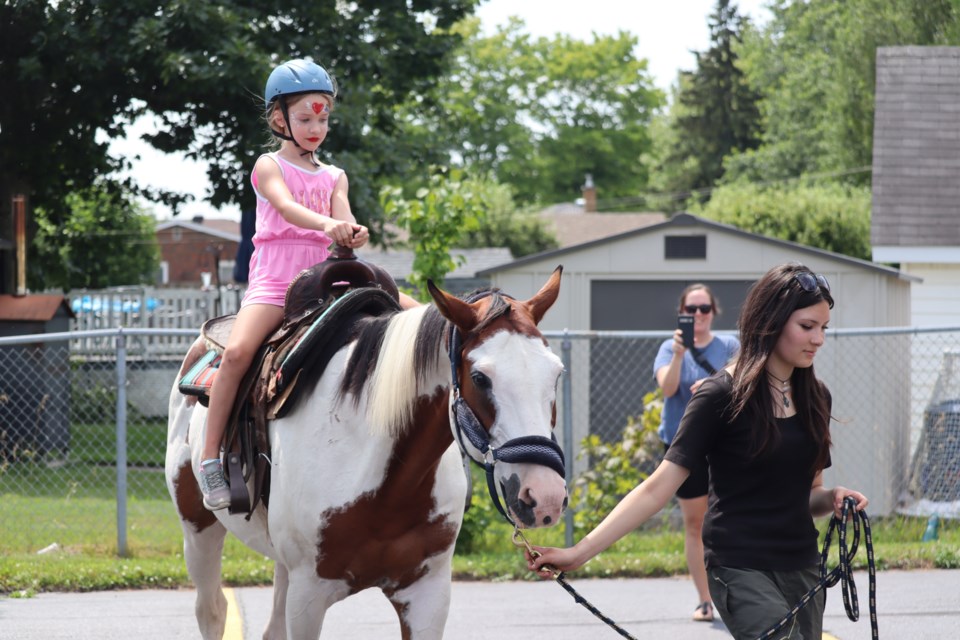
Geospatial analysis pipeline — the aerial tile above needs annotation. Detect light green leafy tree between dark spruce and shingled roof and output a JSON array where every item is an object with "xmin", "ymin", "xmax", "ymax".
[{"xmin": 724, "ymin": 0, "xmax": 960, "ymax": 184}]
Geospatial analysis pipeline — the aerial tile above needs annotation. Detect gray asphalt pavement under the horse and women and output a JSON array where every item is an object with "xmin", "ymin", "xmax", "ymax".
[{"xmin": 0, "ymin": 570, "xmax": 960, "ymax": 640}]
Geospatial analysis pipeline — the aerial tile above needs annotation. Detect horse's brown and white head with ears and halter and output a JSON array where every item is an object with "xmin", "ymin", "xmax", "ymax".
[{"xmin": 428, "ymin": 267, "xmax": 567, "ymax": 527}]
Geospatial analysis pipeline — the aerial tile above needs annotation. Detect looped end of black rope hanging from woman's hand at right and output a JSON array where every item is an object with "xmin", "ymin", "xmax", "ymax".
[{"xmin": 757, "ymin": 496, "xmax": 880, "ymax": 640}]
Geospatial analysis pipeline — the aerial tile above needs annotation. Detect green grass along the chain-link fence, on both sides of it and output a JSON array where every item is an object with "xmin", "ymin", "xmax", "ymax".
[{"xmin": 0, "ymin": 423, "xmax": 960, "ymax": 597}]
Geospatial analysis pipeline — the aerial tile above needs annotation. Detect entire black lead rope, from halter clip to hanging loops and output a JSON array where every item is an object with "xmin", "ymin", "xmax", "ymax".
[{"xmin": 513, "ymin": 496, "xmax": 880, "ymax": 640}]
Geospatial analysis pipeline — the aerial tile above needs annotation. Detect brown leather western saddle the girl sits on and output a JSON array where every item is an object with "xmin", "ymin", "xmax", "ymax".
[{"xmin": 179, "ymin": 247, "xmax": 400, "ymax": 519}]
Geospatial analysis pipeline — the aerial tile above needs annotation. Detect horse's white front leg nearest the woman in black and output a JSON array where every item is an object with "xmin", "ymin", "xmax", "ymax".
[{"xmin": 386, "ymin": 559, "xmax": 451, "ymax": 640}]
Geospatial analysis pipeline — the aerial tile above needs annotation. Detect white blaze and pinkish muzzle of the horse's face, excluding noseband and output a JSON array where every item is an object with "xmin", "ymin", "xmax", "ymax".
[{"xmin": 469, "ymin": 331, "xmax": 567, "ymax": 527}]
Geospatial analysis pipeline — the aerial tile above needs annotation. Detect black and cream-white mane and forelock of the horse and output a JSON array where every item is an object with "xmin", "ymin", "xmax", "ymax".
[{"xmin": 339, "ymin": 289, "xmax": 510, "ymax": 436}]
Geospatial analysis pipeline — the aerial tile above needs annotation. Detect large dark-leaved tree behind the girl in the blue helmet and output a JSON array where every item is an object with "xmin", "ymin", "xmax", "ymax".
[{"xmin": 0, "ymin": 0, "xmax": 476, "ymax": 288}]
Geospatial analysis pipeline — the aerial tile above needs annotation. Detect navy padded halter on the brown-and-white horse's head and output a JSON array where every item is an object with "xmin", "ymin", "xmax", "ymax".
[{"xmin": 449, "ymin": 291, "xmax": 566, "ymax": 527}]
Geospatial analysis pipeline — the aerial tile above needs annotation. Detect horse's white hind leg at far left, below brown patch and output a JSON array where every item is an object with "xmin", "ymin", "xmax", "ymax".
[{"xmin": 183, "ymin": 522, "xmax": 227, "ymax": 640}]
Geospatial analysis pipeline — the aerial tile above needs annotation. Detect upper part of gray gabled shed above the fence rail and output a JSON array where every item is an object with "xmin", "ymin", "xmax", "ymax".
[{"xmin": 477, "ymin": 213, "xmax": 917, "ymax": 330}]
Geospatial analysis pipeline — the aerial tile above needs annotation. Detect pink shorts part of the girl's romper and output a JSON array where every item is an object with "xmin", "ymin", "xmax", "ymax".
[{"xmin": 240, "ymin": 240, "xmax": 330, "ymax": 307}]
